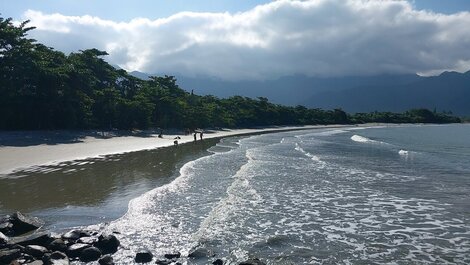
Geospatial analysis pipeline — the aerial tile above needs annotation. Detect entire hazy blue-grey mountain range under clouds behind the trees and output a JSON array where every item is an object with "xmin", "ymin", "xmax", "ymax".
[{"xmin": 131, "ymin": 71, "xmax": 470, "ymax": 116}]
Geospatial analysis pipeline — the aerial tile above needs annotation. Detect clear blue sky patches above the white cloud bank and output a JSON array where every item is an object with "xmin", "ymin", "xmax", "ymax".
[{"xmin": 0, "ymin": 0, "xmax": 470, "ymax": 21}]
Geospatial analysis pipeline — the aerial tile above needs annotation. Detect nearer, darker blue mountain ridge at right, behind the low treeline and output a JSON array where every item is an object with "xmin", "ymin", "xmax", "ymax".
[{"xmin": 303, "ymin": 71, "xmax": 470, "ymax": 116}]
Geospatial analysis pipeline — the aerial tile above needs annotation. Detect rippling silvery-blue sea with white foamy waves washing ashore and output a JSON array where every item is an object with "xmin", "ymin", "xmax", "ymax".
[{"xmin": 106, "ymin": 125, "xmax": 470, "ymax": 264}]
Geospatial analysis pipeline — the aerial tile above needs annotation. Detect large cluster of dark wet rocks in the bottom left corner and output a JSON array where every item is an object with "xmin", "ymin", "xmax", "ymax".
[{"xmin": 0, "ymin": 212, "xmax": 120, "ymax": 265}]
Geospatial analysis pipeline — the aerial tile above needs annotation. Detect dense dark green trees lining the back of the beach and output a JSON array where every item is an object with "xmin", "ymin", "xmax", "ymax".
[{"xmin": 0, "ymin": 17, "xmax": 459, "ymax": 130}]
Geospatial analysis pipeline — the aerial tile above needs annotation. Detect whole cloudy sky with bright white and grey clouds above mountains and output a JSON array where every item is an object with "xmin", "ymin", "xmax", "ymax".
[{"xmin": 0, "ymin": 0, "xmax": 470, "ymax": 80}]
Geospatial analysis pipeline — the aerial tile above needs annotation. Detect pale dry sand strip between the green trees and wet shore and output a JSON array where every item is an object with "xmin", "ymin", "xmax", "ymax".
[{"xmin": 0, "ymin": 125, "xmax": 354, "ymax": 176}]
